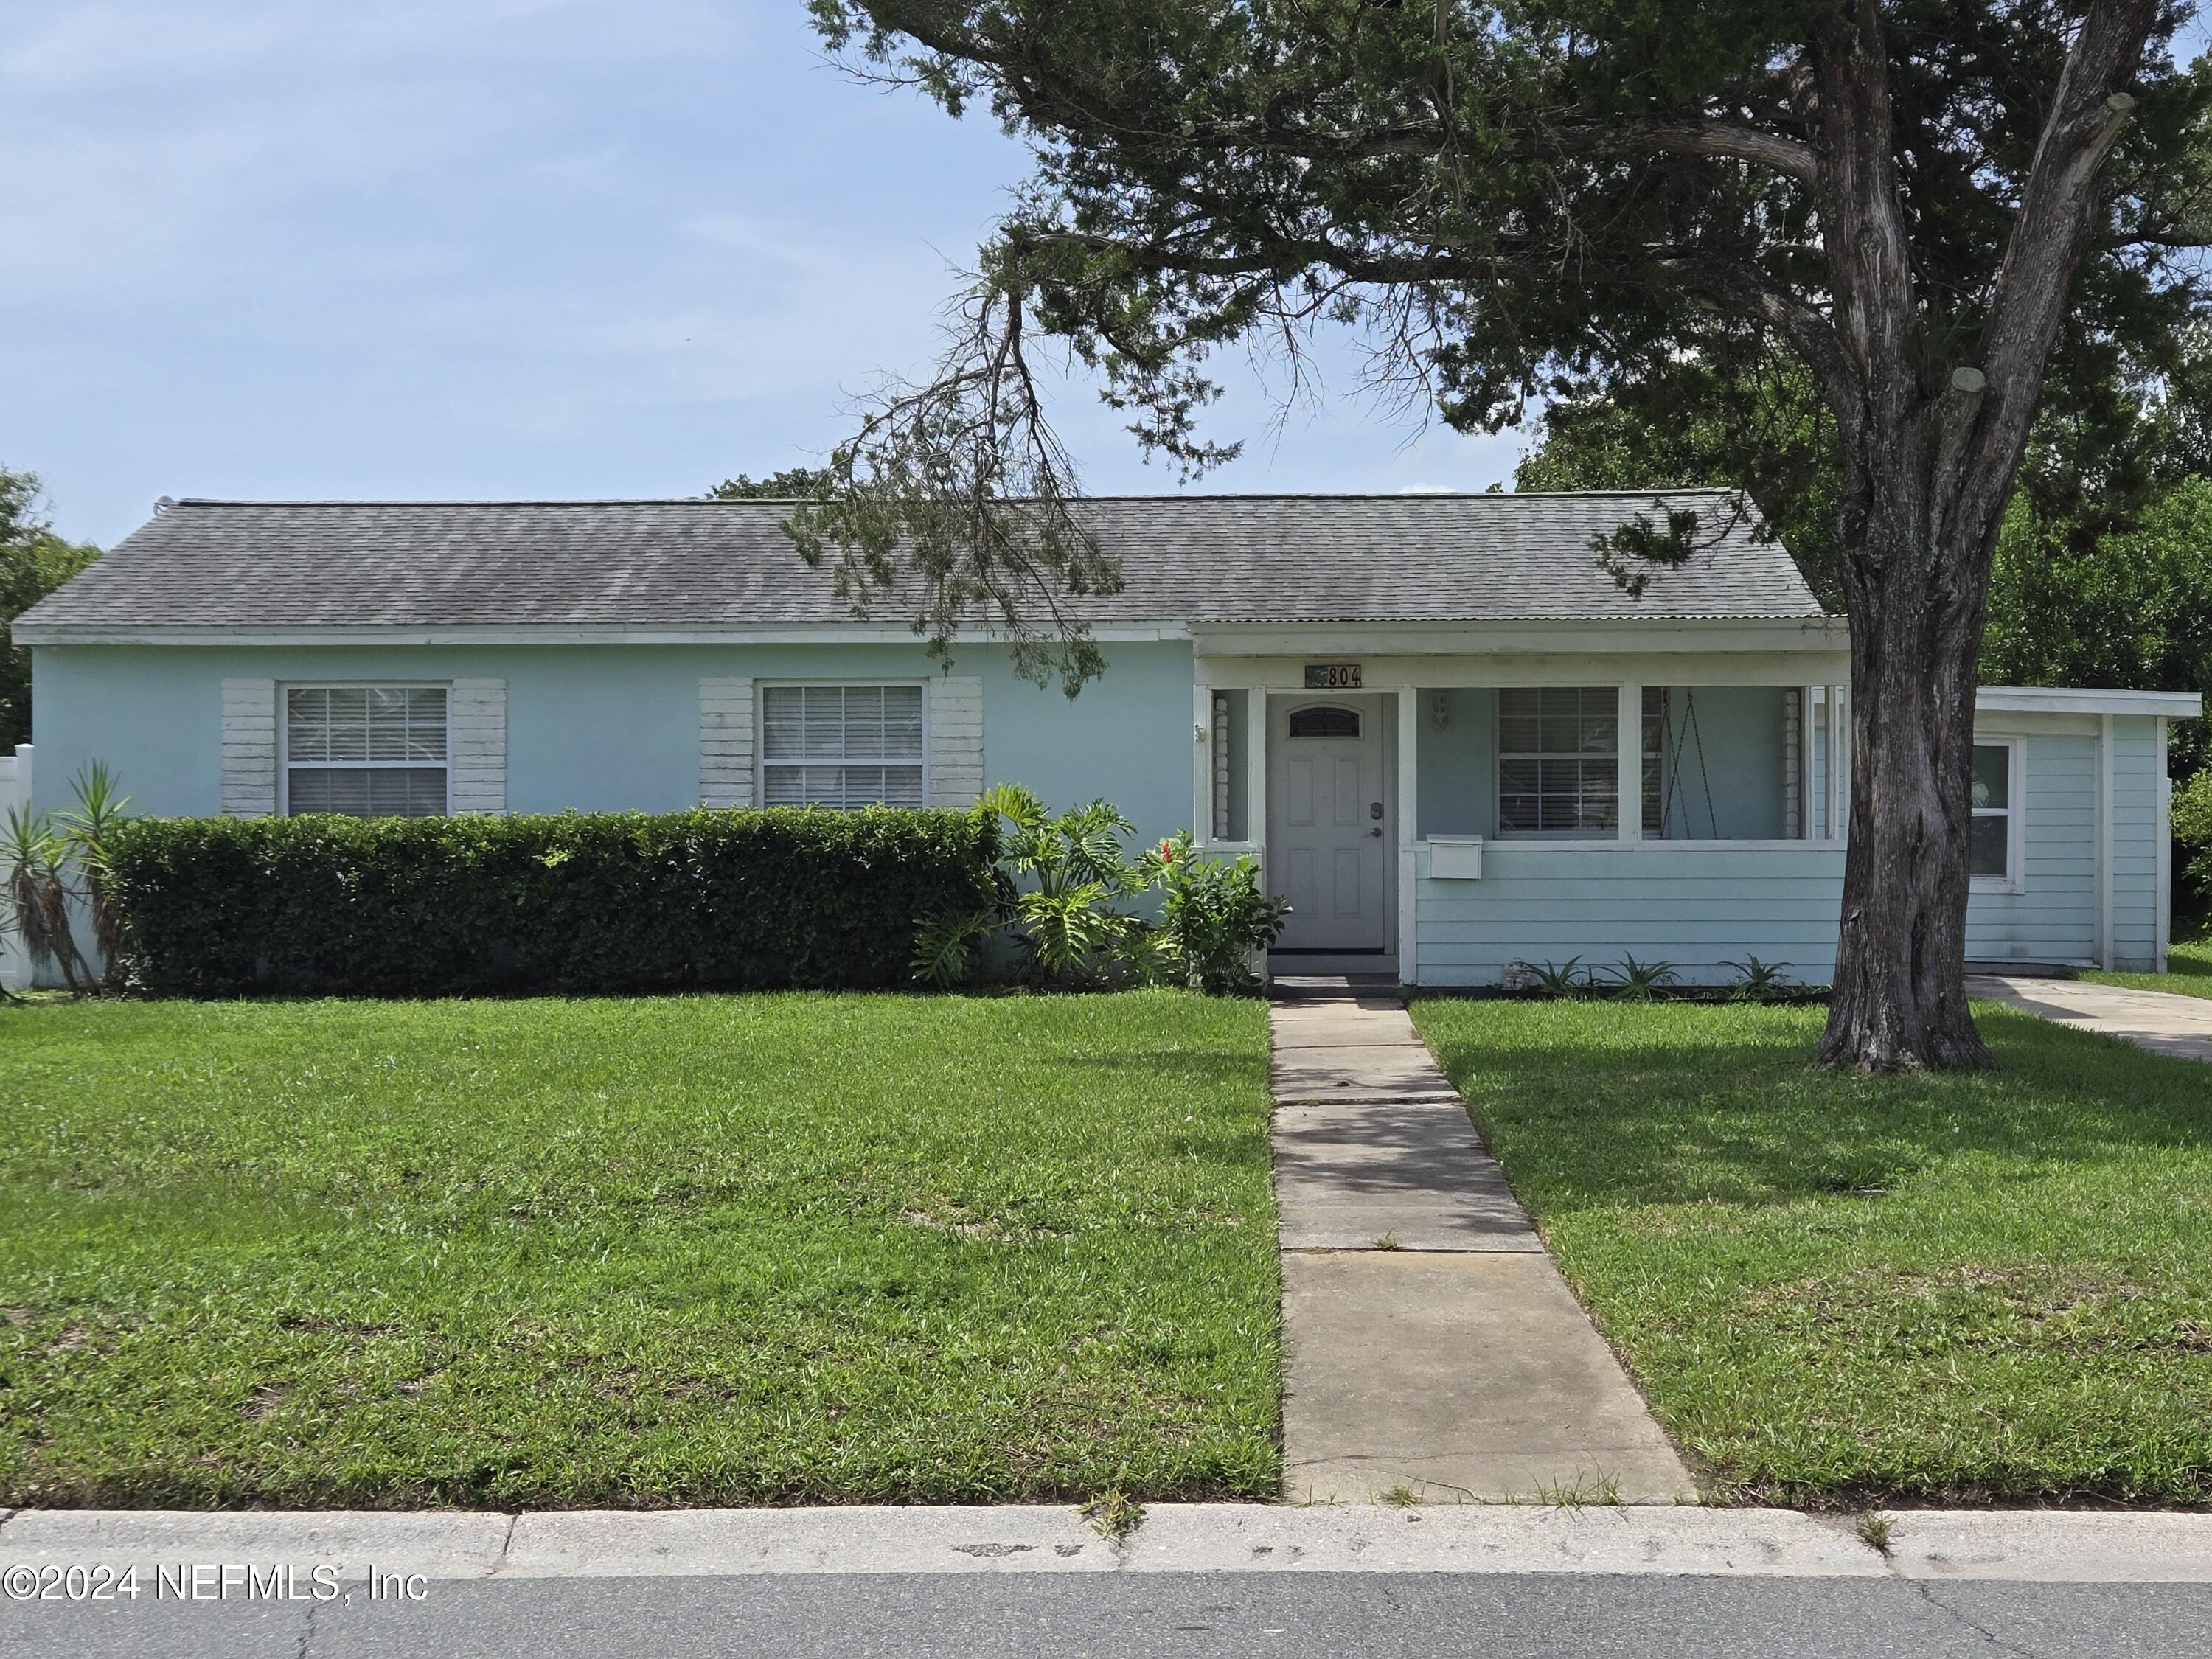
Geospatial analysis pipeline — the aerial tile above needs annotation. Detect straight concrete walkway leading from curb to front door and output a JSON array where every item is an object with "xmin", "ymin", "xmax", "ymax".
[{"xmin": 1270, "ymin": 991, "xmax": 1697, "ymax": 1504}]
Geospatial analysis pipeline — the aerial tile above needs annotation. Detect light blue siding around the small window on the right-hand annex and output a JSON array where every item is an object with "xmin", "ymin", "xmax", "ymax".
[{"xmin": 1966, "ymin": 721, "xmax": 2097, "ymax": 962}]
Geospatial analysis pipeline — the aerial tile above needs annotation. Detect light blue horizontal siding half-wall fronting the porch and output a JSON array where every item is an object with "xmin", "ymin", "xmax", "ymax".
[{"xmin": 1416, "ymin": 843, "xmax": 1843, "ymax": 984}]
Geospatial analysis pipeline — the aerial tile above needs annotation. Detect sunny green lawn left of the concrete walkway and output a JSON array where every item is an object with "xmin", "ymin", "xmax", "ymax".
[{"xmin": 0, "ymin": 993, "xmax": 1281, "ymax": 1506}]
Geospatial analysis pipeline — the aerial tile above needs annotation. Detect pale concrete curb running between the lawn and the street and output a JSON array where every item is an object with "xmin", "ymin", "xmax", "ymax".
[{"xmin": 0, "ymin": 1504, "xmax": 2212, "ymax": 1584}]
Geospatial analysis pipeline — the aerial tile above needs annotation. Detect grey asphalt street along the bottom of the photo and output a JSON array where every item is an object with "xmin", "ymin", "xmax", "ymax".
[{"xmin": 0, "ymin": 1573, "xmax": 2212, "ymax": 1659}]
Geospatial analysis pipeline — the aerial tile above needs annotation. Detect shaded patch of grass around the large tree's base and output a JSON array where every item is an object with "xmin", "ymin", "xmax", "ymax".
[{"xmin": 1425, "ymin": 1004, "xmax": 2212, "ymax": 1219}]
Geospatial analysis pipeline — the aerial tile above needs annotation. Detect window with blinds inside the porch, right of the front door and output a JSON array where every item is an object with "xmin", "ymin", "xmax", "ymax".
[{"xmin": 1498, "ymin": 686, "xmax": 1621, "ymax": 836}]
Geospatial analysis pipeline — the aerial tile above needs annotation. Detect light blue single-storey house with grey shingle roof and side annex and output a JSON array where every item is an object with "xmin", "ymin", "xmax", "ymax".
[{"xmin": 15, "ymin": 491, "xmax": 2199, "ymax": 984}]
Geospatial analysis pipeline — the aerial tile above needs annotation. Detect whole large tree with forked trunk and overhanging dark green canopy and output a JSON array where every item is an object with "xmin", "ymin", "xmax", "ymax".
[{"xmin": 794, "ymin": 0, "xmax": 2205, "ymax": 1068}]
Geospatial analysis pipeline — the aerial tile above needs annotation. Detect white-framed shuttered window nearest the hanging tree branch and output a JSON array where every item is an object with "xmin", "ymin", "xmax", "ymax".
[{"xmin": 761, "ymin": 686, "xmax": 925, "ymax": 807}]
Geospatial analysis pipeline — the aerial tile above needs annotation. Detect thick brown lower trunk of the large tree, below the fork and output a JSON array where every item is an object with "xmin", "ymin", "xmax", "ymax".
[{"xmin": 1820, "ymin": 436, "xmax": 1995, "ymax": 1073}]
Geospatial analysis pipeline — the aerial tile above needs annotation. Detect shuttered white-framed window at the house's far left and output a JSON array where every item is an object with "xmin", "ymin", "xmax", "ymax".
[{"xmin": 283, "ymin": 686, "xmax": 447, "ymax": 818}]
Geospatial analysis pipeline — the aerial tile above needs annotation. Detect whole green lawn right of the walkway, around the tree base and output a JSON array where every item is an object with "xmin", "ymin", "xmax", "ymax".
[{"xmin": 1416, "ymin": 1000, "xmax": 2212, "ymax": 1504}]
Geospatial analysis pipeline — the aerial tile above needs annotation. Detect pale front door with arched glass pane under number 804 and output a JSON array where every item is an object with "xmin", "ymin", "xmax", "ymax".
[{"xmin": 1267, "ymin": 697, "xmax": 1391, "ymax": 953}]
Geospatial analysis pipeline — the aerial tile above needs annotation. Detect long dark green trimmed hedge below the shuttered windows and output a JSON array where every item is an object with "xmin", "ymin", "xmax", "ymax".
[{"xmin": 113, "ymin": 807, "xmax": 998, "ymax": 998}]
